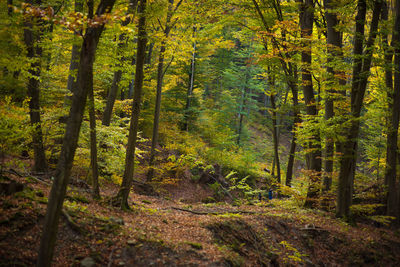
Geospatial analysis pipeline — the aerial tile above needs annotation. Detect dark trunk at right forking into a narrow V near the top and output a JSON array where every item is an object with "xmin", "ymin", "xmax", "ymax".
[{"xmin": 336, "ymin": 0, "xmax": 382, "ymax": 218}]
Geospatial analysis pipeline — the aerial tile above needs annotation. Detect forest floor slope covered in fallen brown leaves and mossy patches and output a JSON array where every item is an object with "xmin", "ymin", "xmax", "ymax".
[{"xmin": 0, "ymin": 162, "xmax": 400, "ymax": 266}]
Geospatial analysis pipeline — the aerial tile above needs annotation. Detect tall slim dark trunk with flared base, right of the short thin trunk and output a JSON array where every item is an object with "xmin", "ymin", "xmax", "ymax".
[{"xmin": 114, "ymin": 0, "xmax": 147, "ymax": 209}]
